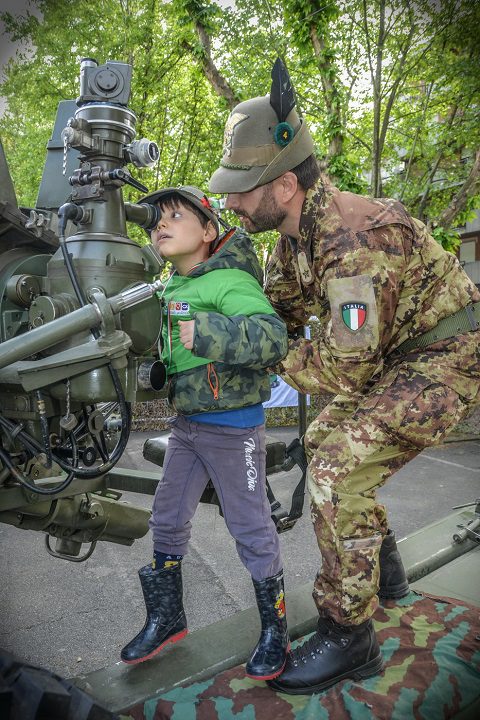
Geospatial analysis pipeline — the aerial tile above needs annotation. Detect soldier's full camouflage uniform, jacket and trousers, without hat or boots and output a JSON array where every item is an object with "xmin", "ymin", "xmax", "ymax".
[{"xmin": 265, "ymin": 182, "xmax": 480, "ymax": 625}]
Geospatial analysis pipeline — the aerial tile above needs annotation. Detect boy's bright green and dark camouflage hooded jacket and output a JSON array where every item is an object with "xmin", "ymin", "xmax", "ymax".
[{"xmin": 162, "ymin": 230, "xmax": 287, "ymax": 415}]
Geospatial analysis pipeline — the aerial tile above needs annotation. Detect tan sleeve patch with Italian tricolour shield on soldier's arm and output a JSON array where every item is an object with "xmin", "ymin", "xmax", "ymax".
[{"xmin": 327, "ymin": 275, "xmax": 379, "ymax": 353}]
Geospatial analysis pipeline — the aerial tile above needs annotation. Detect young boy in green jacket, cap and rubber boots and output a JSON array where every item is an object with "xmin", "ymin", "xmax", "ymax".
[{"xmin": 121, "ymin": 187, "xmax": 289, "ymax": 680}]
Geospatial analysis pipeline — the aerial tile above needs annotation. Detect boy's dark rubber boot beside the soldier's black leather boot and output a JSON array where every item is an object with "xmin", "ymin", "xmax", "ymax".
[{"xmin": 245, "ymin": 571, "xmax": 290, "ymax": 680}]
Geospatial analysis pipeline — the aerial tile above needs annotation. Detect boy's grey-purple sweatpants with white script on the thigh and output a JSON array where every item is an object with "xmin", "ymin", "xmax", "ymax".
[{"xmin": 150, "ymin": 416, "xmax": 282, "ymax": 580}]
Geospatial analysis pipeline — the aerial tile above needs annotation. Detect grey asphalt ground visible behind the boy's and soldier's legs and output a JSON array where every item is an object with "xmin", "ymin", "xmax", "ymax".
[{"xmin": 0, "ymin": 428, "xmax": 480, "ymax": 676}]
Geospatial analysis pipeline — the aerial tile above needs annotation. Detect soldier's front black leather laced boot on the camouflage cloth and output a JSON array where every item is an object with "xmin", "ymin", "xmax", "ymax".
[{"xmin": 268, "ymin": 618, "xmax": 383, "ymax": 695}]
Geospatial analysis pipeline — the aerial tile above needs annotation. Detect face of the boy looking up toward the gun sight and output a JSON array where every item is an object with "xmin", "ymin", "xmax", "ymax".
[{"xmin": 151, "ymin": 203, "xmax": 217, "ymax": 275}]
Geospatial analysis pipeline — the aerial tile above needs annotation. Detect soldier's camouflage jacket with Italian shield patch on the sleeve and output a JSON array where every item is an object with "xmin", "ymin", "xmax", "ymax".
[{"xmin": 265, "ymin": 182, "xmax": 480, "ymax": 399}]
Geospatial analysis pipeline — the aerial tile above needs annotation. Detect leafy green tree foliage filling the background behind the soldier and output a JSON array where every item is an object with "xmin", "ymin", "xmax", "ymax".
[{"xmin": 0, "ymin": 0, "xmax": 480, "ymax": 245}]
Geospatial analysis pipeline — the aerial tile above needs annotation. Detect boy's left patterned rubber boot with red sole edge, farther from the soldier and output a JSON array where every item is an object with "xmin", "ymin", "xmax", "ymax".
[{"xmin": 121, "ymin": 563, "xmax": 187, "ymax": 664}]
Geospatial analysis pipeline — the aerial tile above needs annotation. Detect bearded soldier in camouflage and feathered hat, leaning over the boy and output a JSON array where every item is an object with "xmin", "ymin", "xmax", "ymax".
[{"xmin": 210, "ymin": 61, "xmax": 480, "ymax": 694}]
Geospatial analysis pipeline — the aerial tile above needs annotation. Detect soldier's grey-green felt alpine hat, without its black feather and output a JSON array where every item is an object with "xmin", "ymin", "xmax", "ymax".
[{"xmin": 208, "ymin": 95, "xmax": 315, "ymax": 193}]
